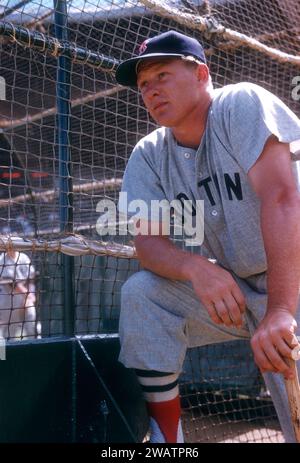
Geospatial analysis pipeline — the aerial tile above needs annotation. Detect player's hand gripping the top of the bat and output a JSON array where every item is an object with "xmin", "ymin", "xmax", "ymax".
[{"xmin": 251, "ymin": 309, "xmax": 299, "ymax": 379}]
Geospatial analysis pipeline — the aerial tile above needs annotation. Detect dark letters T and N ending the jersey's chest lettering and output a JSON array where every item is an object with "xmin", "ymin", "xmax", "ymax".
[{"xmin": 198, "ymin": 172, "xmax": 243, "ymax": 206}]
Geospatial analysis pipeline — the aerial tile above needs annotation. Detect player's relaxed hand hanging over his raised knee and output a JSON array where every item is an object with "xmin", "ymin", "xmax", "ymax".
[{"xmin": 190, "ymin": 260, "xmax": 246, "ymax": 328}]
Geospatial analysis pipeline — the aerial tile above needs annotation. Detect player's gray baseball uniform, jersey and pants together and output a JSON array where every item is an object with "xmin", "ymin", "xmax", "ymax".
[{"xmin": 119, "ymin": 83, "xmax": 300, "ymax": 441}]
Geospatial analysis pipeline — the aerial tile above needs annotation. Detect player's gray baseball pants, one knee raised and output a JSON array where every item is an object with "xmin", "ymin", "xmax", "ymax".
[{"xmin": 119, "ymin": 270, "xmax": 300, "ymax": 442}]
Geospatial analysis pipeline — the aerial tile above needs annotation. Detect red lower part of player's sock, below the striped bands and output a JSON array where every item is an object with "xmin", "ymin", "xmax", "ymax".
[{"xmin": 147, "ymin": 395, "xmax": 181, "ymax": 443}]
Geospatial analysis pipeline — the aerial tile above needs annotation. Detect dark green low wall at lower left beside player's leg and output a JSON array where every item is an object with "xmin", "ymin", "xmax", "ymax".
[{"xmin": 0, "ymin": 337, "xmax": 147, "ymax": 443}]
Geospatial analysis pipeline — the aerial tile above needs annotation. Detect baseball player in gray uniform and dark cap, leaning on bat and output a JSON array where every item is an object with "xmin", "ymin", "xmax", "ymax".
[{"xmin": 116, "ymin": 31, "xmax": 300, "ymax": 442}]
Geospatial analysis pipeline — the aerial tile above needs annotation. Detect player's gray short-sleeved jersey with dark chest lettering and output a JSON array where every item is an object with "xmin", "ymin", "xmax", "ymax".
[{"xmin": 119, "ymin": 82, "xmax": 300, "ymax": 278}]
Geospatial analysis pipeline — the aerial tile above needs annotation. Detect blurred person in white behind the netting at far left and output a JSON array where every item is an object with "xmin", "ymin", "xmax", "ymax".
[{"xmin": 0, "ymin": 250, "xmax": 41, "ymax": 340}]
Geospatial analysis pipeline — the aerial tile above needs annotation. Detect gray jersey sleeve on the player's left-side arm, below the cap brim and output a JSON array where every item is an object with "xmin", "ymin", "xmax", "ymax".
[{"xmin": 118, "ymin": 140, "xmax": 166, "ymax": 221}]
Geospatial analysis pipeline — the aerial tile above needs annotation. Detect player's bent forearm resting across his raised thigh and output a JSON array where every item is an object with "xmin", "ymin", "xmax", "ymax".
[{"xmin": 135, "ymin": 236, "xmax": 206, "ymax": 281}]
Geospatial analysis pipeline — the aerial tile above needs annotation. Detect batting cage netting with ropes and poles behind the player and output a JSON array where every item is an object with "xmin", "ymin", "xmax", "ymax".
[{"xmin": 0, "ymin": 0, "xmax": 300, "ymax": 442}]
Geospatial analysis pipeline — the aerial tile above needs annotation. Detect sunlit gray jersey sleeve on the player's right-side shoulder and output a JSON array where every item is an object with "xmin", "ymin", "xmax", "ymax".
[{"xmin": 219, "ymin": 83, "xmax": 300, "ymax": 172}]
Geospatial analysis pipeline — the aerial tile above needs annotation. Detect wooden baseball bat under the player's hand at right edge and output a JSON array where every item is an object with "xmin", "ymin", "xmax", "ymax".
[{"xmin": 285, "ymin": 346, "xmax": 300, "ymax": 443}]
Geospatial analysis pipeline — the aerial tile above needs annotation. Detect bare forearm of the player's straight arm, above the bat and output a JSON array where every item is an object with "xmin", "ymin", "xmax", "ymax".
[{"xmin": 261, "ymin": 195, "xmax": 300, "ymax": 314}]
